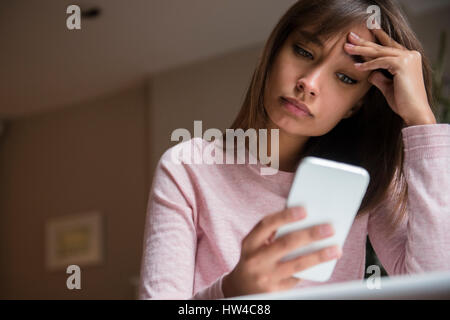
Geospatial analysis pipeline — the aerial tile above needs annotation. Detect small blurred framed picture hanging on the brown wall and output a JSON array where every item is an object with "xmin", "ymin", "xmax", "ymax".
[{"xmin": 45, "ymin": 212, "xmax": 103, "ymax": 270}]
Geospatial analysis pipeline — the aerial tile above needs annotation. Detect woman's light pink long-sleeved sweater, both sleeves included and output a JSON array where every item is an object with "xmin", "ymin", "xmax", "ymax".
[{"xmin": 139, "ymin": 124, "xmax": 450, "ymax": 299}]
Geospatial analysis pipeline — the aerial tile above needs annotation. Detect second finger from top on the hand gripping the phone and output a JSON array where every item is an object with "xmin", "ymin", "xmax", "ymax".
[{"xmin": 257, "ymin": 224, "xmax": 334, "ymax": 262}]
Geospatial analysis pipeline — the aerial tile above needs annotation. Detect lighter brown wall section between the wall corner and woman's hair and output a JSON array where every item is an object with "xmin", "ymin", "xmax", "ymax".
[{"xmin": 149, "ymin": 44, "xmax": 263, "ymax": 172}]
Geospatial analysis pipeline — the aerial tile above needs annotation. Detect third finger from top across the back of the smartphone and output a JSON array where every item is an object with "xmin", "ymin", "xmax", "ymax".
[{"xmin": 276, "ymin": 245, "xmax": 342, "ymax": 279}]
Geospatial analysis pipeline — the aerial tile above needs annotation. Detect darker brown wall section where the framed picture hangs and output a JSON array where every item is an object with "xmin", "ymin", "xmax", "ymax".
[{"xmin": 0, "ymin": 85, "xmax": 148, "ymax": 299}]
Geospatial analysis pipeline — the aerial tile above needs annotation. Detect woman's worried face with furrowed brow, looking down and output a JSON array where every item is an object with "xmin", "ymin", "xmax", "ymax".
[{"xmin": 264, "ymin": 25, "xmax": 375, "ymax": 136}]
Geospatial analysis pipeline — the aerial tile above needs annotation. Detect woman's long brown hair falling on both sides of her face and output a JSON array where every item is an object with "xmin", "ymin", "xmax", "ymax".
[{"xmin": 225, "ymin": 0, "xmax": 432, "ymax": 235}]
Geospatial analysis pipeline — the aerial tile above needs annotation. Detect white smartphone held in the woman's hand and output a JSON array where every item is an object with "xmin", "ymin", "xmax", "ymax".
[{"xmin": 275, "ymin": 157, "xmax": 370, "ymax": 282}]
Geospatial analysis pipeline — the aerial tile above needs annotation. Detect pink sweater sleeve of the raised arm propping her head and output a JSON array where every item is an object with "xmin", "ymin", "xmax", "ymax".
[{"xmin": 368, "ymin": 124, "xmax": 450, "ymax": 275}]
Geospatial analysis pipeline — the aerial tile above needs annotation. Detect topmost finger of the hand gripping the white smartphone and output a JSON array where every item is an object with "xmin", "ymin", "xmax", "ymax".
[{"xmin": 242, "ymin": 207, "xmax": 306, "ymax": 253}]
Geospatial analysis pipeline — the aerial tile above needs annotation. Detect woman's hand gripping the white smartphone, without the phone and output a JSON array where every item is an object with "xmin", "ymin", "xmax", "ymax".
[{"xmin": 222, "ymin": 207, "xmax": 344, "ymax": 298}]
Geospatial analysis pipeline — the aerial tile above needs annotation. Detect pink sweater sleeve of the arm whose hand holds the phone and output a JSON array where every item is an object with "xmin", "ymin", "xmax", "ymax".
[{"xmin": 139, "ymin": 142, "xmax": 223, "ymax": 300}]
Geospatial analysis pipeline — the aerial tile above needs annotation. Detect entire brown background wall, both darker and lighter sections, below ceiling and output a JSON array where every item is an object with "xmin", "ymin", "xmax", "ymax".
[{"xmin": 0, "ymin": 46, "xmax": 262, "ymax": 299}]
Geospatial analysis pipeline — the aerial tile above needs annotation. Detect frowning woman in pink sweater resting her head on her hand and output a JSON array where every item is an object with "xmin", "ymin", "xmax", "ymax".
[{"xmin": 140, "ymin": 0, "xmax": 450, "ymax": 299}]
